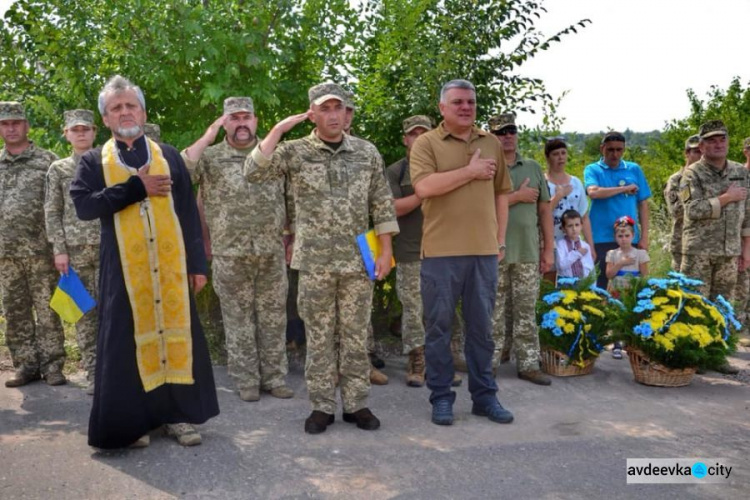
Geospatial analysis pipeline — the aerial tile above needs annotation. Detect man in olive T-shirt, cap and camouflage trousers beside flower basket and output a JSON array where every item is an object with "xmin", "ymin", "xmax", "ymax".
[{"xmin": 489, "ymin": 113, "xmax": 555, "ymax": 385}]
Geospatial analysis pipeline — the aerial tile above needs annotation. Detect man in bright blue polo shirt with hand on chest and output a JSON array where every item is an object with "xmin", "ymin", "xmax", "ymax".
[{"xmin": 583, "ymin": 132, "xmax": 651, "ymax": 288}]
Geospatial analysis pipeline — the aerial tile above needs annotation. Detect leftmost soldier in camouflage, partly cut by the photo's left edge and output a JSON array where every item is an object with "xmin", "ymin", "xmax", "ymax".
[{"xmin": 0, "ymin": 102, "xmax": 65, "ymax": 387}]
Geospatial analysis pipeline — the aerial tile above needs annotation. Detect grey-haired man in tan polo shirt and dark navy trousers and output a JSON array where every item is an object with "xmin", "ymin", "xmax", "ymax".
[{"xmin": 409, "ymin": 80, "xmax": 513, "ymax": 425}]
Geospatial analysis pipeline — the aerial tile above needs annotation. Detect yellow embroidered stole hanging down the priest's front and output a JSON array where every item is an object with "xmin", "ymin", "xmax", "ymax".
[{"xmin": 102, "ymin": 139, "xmax": 193, "ymax": 392}]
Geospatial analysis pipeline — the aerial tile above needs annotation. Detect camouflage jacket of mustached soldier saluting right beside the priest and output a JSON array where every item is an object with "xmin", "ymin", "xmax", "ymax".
[{"xmin": 182, "ymin": 139, "xmax": 286, "ymax": 257}]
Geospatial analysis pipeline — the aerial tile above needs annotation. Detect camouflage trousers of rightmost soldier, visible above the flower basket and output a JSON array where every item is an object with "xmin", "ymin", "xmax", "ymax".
[{"xmin": 680, "ymin": 255, "xmax": 738, "ymax": 300}]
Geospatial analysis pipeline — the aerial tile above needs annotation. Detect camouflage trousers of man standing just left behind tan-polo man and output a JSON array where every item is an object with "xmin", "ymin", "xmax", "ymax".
[{"xmin": 396, "ymin": 261, "xmax": 424, "ymax": 354}]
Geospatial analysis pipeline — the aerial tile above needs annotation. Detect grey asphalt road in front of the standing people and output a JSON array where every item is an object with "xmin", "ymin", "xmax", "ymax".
[{"xmin": 0, "ymin": 348, "xmax": 750, "ymax": 499}]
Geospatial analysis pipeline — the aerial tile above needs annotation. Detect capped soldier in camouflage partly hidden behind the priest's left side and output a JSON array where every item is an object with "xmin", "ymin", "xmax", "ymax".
[{"xmin": 44, "ymin": 109, "xmax": 99, "ymax": 395}]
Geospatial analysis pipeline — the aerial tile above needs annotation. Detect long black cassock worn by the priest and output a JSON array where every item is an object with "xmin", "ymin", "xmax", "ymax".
[{"xmin": 70, "ymin": 137, "xmax": 219, "ymax": 448}]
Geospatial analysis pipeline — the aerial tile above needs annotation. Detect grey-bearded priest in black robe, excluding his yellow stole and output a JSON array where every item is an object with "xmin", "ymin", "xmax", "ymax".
[{"xmin": 70, "ymin": 76, "xmax": 219, "ymax": 449}]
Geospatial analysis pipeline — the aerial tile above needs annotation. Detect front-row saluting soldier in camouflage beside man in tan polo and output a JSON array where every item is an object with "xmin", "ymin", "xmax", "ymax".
[{"xmin": 245, "ymin": 83, "xmax": 398, "ymax": 434}]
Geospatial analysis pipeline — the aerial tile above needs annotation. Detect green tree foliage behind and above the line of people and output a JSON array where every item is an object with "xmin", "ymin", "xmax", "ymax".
[{"xmin": 0, "ymin": 0, "xmax": 589, "ymax": 161}]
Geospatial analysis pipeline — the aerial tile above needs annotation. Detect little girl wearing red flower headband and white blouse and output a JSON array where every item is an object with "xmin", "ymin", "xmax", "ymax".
[{"xmin": 605, "ymin": 215, "xmax": 650, "ymax": 359}]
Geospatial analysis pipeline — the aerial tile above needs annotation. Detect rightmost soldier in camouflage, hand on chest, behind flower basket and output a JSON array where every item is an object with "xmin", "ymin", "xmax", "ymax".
[{"xmin": 680, "ymin": 120, "xmax": 750, "ymax": 374}]
